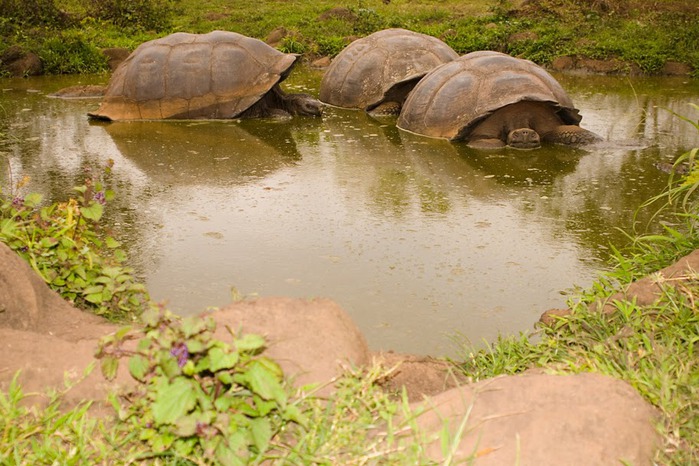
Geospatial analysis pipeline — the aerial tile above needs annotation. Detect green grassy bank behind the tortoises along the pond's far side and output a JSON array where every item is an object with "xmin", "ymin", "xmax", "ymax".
[{"xmin": 0, "ymin": 0, "xmax": 699, "ymax": 74}]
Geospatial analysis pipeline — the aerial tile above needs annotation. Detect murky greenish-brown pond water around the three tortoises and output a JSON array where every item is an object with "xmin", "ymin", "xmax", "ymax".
[{"xmin": 0, "ymin": 69, "xmax": 699, "ymax": 355}]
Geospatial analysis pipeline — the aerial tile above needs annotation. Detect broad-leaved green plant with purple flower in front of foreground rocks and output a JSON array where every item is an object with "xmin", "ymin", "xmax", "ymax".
[{"xmin": 97, "ymin": 306, "xmax": 306, "ymax": 465}]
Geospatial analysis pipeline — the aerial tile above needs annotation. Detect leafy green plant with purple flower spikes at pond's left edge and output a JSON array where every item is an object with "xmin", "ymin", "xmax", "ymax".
[{"xmin": 0, "ymin": 161, "xmax": 149, "ymax": 320}]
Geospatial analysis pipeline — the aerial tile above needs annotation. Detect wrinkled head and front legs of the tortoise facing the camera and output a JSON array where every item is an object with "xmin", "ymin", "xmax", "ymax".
[{"xmin": 462, "ymin": 101, "xmax": 602, "ymax": 149}]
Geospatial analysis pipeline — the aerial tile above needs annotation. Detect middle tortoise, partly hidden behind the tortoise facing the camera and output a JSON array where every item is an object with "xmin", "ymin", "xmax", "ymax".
[{"xmin": 319, "ymin": 29, "xmax": 459, "ymax": 115}]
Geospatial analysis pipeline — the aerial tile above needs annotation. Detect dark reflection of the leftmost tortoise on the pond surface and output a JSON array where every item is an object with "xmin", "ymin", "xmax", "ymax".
[{"xmin": 98, "ymin": 121, "xmax": 301, "ymax": 185}]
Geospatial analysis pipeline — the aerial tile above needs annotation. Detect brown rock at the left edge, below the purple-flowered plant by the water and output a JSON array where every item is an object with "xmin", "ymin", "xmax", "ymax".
[{"xmin": 0, "ymin": 242, "xmax": 132, "ymax": 407}]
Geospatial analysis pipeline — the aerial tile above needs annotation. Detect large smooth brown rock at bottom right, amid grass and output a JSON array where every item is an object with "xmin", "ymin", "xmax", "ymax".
[{"xmin": 411, "ymin": 373, "xmax": 659, "ymax": 466}]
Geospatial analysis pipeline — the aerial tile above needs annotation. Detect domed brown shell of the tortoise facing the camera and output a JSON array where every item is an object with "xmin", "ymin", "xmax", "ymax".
[{"xmin": 397, "ymin": 51, "xmax": 582, "ymax": 140}]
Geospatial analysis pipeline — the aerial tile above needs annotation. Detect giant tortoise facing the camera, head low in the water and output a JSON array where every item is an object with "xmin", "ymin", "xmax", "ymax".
[{"xmin": 397, "ymin": 51, "xmax": 601, "ymax": 149}]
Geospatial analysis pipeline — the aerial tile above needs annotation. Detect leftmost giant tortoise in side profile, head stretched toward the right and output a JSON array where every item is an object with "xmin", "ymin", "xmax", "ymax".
[{"xmin": 88, "ymin": 31, "xmax": 322, "ymax": 120}]
